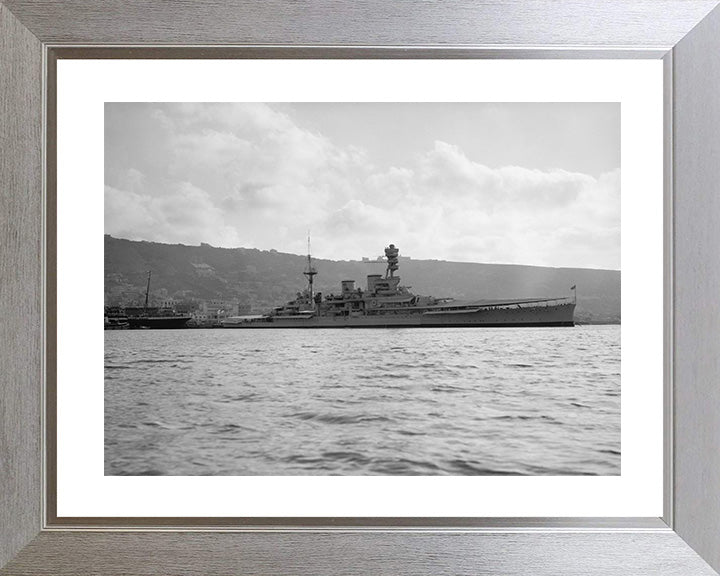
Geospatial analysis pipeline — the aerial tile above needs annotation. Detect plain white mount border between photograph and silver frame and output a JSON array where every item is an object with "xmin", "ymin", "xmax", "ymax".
[{"xmin": 57, "ymin": 60, "xmax": 663, "ymax": 517}]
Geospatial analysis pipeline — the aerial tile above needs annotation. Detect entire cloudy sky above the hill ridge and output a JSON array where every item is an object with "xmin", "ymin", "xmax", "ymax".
[{"xmin": 105, "ymin": 103, "xmax": 620, "ymax": 270}]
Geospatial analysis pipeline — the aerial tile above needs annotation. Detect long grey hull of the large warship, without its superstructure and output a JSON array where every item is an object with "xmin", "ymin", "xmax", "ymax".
[{"xmin": 224, "ymin": 302, "xmax": 575, "ymax": 329}]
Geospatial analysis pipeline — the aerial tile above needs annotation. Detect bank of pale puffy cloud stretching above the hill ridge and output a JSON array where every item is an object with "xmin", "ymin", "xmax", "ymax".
[{"xmin": 105, "ymin": 104, "xmax": 620, "ymax": 268}]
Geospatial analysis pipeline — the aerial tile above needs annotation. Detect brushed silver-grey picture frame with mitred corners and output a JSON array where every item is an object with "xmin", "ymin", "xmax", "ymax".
[{"xmin": 0, "ymin": 0, "xmax": 720, "ymax": 575}]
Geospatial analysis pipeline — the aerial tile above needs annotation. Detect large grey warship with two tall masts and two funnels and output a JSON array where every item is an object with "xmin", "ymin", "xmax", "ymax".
[{"xmin": 222, "ymin": 241, "xmax": 577, "ymax": 328}]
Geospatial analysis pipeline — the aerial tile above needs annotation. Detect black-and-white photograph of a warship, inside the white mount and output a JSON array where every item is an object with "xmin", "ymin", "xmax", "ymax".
[{"xmin": 104, "ymin": 102, "xmax": 621, "ymax": 476}]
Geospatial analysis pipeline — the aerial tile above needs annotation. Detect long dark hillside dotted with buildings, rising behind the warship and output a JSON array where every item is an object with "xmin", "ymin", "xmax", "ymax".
[{"xmin": 105, "ymin": 235, "xmax": 620, "ymax": 323}]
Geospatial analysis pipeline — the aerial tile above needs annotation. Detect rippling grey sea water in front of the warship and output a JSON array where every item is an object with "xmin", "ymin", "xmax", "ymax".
[{"xmin": 105, "ymin": 326, "xmax": 620, "ymax": 475}]
